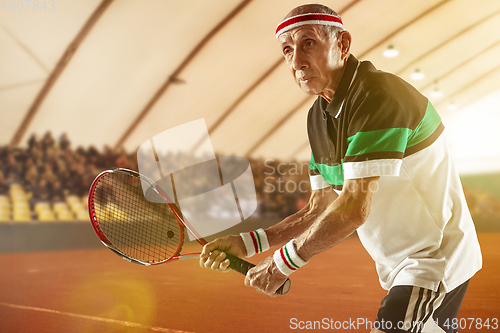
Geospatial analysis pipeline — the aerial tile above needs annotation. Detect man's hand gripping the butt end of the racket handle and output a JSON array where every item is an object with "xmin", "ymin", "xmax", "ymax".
[{"xmin": 245, "ymin": 256, "xmax": 288, "ymax": 297}]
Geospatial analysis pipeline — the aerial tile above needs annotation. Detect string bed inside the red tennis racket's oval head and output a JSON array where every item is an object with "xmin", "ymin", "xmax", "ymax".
[{"xmin": 94, "ymin": 172, "xmax": 183, "ymax": 263}]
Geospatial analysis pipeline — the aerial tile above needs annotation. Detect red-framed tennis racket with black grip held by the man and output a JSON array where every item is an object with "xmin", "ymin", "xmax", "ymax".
[{"xmin": 88, "ymin": 168, "xmax": 291, "ymax": 295}]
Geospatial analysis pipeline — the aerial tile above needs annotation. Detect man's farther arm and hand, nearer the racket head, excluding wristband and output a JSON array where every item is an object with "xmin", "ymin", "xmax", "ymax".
[{"xmin": 200, "ymin": 187, "xmax": 338, "ymax": 272}]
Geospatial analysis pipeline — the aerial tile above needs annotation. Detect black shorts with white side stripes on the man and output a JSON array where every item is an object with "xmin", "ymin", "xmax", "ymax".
[{"xmin": 373, "ymin": 281, "xmax": 469, "ymax": 333}]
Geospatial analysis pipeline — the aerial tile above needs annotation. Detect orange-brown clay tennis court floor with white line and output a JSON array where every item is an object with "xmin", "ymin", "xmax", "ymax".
[{"xmin": 0, "ymin": 231, "xmax": 500, "ymax": 333}]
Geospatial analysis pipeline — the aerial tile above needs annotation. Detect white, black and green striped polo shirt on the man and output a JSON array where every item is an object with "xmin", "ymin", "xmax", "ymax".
[{"xmin": 307, "ymin": 55, "xmax": 482, "ymax": 291}]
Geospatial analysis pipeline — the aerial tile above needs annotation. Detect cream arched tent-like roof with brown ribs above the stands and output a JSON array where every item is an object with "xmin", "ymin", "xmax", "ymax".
[{"xmin": 0, "ymin": 0, "xmax": 500, "ymax": 167}]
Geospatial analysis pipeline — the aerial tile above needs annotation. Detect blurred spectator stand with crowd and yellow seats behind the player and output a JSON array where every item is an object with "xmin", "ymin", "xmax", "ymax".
[{"xmin": 0, "ymin": 132, "xmax": 500, "ymax": 232}]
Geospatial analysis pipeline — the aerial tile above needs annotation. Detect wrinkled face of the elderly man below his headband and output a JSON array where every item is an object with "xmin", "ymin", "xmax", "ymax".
[{"xmin": 279, "ymin": 25, "xmax": 343, "ymax": 96}]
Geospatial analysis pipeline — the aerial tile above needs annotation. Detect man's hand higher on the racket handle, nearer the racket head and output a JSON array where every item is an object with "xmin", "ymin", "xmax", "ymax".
[{"xmin": 200, "ymin": 235, "xmax": 247, "ymax": 272}]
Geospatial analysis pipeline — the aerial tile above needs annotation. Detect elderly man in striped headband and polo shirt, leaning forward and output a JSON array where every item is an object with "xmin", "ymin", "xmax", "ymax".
[{"xmin": 200, "ymin": 5, "xmax": 482, "ymax": 332}]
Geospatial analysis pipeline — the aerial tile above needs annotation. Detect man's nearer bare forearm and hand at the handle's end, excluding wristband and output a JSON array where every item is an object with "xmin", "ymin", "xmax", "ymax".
[{"xmin": 245, "ymin": 177, "xmax": 379, "ymax": 296}]
